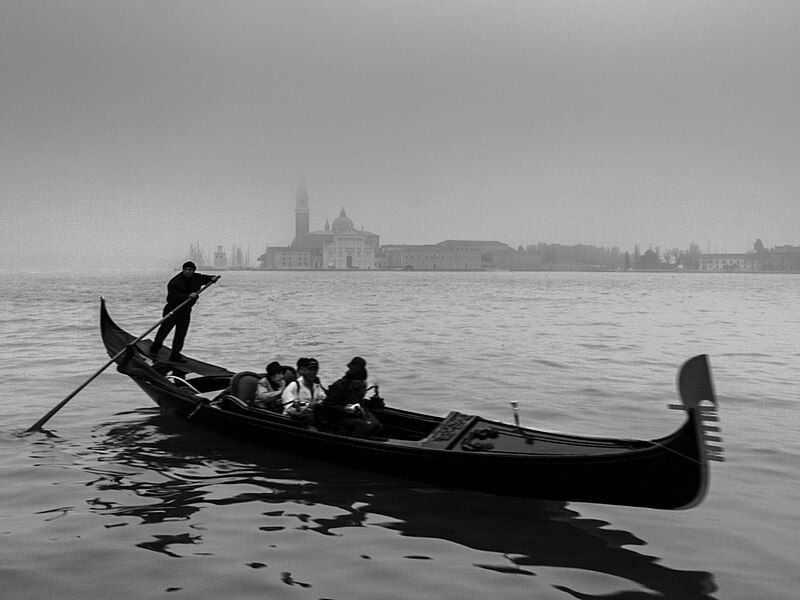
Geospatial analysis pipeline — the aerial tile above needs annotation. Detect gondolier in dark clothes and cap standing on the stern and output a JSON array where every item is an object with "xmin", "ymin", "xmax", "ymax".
[{"xmin": 149, "ymin": 261, "xmax": 219, "ymax": 362}]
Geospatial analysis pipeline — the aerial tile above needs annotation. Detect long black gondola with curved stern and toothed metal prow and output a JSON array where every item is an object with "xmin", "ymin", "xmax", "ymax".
[{"xmin": 100, "ymin": 300, "xmax": 722, "ymax": 510}]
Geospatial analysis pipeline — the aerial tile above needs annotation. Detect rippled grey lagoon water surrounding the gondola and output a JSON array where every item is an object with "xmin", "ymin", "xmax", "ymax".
[{"xmin": 0, "ymin": 272, "xmax": 800, "ymax": 600}]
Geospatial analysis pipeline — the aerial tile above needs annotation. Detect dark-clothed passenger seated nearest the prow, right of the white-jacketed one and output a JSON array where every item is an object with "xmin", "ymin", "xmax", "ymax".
[{"xmin": 316, "ymin": 356, "xmax": 382, "ymax": 437}]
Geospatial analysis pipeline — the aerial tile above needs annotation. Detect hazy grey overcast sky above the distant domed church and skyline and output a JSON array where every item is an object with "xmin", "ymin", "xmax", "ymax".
[{"xmin": 0, "ymin": 0, "xmax": 800, "ymax": 269}]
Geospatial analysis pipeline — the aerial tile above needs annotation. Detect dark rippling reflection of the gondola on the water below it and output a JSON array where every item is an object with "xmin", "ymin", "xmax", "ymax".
[{"xmin": 94, "ymin": 416, "xmax": 716, "ymax": 599}]
